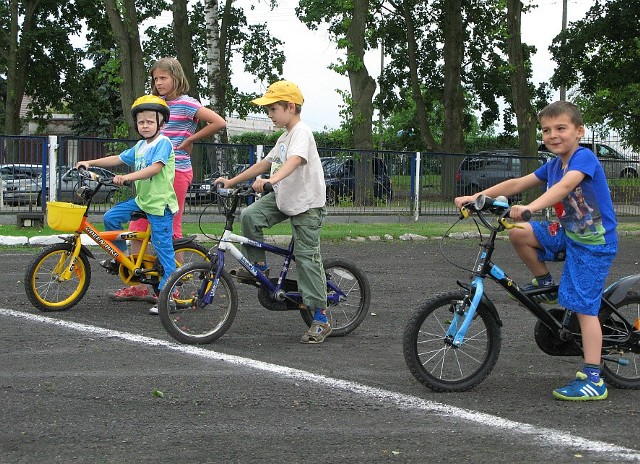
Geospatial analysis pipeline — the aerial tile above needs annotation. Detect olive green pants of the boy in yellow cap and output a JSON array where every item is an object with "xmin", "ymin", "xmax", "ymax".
[{"xmin": 240, "ymin": 193, "xmax": 327, "ymax": 308}]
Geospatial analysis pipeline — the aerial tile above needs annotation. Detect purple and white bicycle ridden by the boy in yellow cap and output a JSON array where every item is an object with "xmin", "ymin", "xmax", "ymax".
[{"xmin": 158, "ymin": 184, "xmax": 371, "ymax": 344}]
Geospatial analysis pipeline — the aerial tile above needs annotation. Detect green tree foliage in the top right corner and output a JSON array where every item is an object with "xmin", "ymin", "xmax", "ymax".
[{"xmin": 550, "ymin": 0, "xmax": 640, "ymax": 149}]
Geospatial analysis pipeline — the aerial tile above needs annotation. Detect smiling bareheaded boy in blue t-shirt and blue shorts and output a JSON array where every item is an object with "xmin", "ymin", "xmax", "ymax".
[{"xmin": 455, "ymin": 101, "xmax": 618, "ymax": 401}]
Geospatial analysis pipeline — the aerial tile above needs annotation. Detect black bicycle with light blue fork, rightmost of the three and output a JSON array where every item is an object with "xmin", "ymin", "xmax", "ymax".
[{"xmin": 403, "ymin": 196, "xmax": 640, "ymax": 392}]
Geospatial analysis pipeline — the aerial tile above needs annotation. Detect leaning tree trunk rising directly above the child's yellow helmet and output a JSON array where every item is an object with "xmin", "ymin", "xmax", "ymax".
[{"xmin": 104, "ymin": 0, "xmax": 146, "ymax": 138}]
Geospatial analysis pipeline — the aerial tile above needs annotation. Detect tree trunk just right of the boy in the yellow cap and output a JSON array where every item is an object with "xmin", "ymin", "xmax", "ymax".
[{"xmin": 347, "ymin": 0, "xmax": 376, "ymax": 205}]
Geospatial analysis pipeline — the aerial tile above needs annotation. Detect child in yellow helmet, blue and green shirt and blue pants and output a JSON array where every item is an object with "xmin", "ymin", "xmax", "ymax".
[{"xmin": 76, "ymin": 95, "xmax": 178, "ymax": 314}]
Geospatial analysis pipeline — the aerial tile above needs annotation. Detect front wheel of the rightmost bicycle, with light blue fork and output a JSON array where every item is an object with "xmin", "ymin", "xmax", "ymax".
[{"xmin": 403, "ymin": 290, "xmax": 501, "ymax": 392}]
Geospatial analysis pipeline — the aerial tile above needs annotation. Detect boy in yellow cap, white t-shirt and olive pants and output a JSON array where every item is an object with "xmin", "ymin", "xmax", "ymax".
[{"xmin": 216, "ymin": 81, "xmax": 332, "ymax": 343}]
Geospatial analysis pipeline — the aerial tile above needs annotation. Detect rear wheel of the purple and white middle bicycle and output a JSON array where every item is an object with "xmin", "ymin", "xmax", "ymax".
[{"xmin": 300, "ymin": 258, "xmax": 371, "ymax": 337}]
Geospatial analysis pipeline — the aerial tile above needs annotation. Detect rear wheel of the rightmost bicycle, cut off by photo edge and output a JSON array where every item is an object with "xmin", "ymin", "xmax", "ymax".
[{"xmin": 599, "ymin": 292, "xmax": 640, "ymax": 390}]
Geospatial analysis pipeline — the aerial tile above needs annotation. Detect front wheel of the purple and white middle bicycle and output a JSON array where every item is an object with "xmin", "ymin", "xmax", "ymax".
[{"xmin": 158, "ymin": 261, "xmax": 238, "ymax": 345}]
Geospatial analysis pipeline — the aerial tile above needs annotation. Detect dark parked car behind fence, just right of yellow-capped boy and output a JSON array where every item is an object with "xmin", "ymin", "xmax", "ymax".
[{"xmin": 321, "ymin": 156, "xmax": 393, "ymax": 206}]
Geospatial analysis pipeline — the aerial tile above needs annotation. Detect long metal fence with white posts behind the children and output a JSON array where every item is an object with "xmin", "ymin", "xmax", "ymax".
[{"xmin": 0, "ymin": 136, "xmax": 640, "ymax": 220}]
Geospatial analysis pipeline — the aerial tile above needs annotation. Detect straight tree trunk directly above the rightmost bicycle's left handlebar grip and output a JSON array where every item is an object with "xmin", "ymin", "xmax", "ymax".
[{"xmin": 441, "ymin": 0, "xmax": 464, "ymax": 198}]
